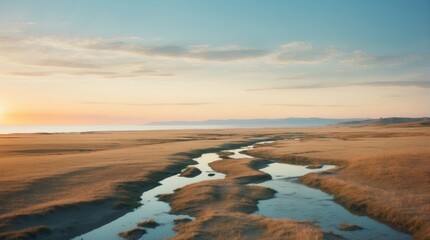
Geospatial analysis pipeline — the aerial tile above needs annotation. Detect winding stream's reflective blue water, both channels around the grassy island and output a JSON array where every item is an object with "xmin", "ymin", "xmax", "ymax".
[{"xmin": 74, "ymin": 142, "xmax": 411, "ymax": 240}]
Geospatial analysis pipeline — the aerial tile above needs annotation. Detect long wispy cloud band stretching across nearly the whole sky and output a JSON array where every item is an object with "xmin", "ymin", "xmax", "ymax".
[{"xmin": 0, "ymin": 34, "xmax": 424, "ymax": 80}]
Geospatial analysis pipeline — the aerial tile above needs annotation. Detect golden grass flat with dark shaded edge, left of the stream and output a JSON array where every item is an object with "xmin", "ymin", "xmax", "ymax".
[{"xmin": 0, "ymin": 129, "xmax": 294, "ymax": 239}]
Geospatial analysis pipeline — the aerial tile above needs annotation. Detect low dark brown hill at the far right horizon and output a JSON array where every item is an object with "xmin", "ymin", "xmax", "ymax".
[{"xmin": 340, "ymin": 117, "xmax": 430, "ymax": 127}]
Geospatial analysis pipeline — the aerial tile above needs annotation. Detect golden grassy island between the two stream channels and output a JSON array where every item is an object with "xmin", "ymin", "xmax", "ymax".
[{"xmin": 160, "ymin": 155, "xmax": 323, "ymax": 240}]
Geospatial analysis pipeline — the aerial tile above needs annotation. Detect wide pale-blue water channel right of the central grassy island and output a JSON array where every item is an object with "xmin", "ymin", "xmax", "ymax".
[{"xmin": 255, "ymin": 163, "xmax": 411, "ymax": 240}]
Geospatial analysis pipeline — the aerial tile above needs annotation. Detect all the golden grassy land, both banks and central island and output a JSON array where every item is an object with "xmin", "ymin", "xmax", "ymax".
[{"xmin": 0, "ymin": 125, "xmax": 430, "ymax": 239}]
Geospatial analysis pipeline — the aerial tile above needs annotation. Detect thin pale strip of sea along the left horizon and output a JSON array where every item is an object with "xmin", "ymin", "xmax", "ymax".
[{"xmin": 0, "ymin": 125, "xmax": 232, "ymax": 134}]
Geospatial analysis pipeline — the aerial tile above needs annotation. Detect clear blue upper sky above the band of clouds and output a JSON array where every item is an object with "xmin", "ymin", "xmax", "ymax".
[{"xmin": 0, "ymin": 0, "xmax": 430, "ymax": 50}]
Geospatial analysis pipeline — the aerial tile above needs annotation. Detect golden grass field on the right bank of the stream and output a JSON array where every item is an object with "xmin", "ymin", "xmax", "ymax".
[{"xmin": 245, "ymin": 124, "xmax": 430, "ymax": 239}]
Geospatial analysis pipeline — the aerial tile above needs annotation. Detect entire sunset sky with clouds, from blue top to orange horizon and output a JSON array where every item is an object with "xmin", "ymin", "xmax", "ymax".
[{"xmin": 0, "ymin": 0, "xmax": 430, "ymax": 125}]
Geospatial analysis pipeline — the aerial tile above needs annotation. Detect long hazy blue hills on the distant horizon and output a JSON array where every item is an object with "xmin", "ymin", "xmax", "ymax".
[{"xmin": 145, "ymin": 118, "xmax": 367, "ymax": 128}]
